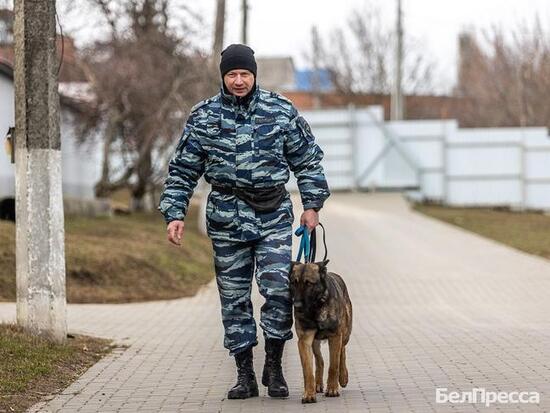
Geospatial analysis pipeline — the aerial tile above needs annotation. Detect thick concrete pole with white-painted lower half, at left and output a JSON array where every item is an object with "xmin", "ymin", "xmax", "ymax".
[{"xmin": 14, "ymin": 0, "xmax": 67, "ymax": 343}]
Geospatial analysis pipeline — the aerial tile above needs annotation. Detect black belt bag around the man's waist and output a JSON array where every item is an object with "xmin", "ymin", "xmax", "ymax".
[{"xmin": 212, "ymin": 184, "xmax": 287, "ymax": 212}]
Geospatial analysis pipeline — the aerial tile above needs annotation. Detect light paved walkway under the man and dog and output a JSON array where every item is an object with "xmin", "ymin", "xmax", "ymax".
[{"xmin": 0, "ymin": 194, "xmax": 550, "ymax": 413}]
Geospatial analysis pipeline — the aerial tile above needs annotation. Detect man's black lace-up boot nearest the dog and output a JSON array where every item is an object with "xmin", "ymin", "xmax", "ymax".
[{"xmin": 262, "ymin": 338, "xmax": 288, "ymax": 397}]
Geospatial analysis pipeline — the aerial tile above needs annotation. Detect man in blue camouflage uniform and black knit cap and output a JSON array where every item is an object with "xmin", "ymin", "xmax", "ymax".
[{"xmin": 159, "ymin": 45, "xmax": 330, "ymax": 398}]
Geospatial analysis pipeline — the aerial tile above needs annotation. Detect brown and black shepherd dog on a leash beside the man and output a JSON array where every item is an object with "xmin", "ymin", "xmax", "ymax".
[{"xmin": 290, "ymin": 260, "xmax": 352, "ymax": 403}]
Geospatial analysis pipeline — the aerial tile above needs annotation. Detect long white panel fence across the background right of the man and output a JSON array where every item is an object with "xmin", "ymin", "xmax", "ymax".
[{"xmin": 290, "ymin": 107, "xmax": 550, "ymax": 210}]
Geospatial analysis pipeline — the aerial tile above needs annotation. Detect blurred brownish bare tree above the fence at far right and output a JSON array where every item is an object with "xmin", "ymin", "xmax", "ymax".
[{"xmin": 455, "ymin": 17, "xmax": 550, "ymax": 126}]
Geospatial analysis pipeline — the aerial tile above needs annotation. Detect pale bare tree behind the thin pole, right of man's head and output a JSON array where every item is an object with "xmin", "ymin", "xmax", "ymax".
[{"xmin": 312, "ymin": 3, "xmax": 434, "ymax": 95}]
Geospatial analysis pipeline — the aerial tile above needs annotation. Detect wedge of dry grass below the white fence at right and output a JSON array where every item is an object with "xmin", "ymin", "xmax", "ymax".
[{"xmin": 413, "ymin": 204, "xmax": 550, "ymax": 259}]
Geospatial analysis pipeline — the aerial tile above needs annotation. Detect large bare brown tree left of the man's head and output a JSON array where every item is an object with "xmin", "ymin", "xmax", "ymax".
[{"xmin": 76, "ymin": 0, "xmax": 216, "ymax": 210}]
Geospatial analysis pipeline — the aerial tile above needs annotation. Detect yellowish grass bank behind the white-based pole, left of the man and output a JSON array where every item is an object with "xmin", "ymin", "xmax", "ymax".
[{"xmin": 0, "ymin": 207, "xmax": 214, "ymax": 303}]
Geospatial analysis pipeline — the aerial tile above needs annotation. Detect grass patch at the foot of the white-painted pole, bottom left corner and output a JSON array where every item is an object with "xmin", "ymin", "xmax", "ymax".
[{"xmin": 0, "ymin": 324, "xmax": 112, "ymax": 412}]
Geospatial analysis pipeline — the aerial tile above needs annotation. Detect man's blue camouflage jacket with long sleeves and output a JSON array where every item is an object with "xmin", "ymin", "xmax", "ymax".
[{"xmin": 159, "ymin": 87, "xmax": 330, "ymax": 241}]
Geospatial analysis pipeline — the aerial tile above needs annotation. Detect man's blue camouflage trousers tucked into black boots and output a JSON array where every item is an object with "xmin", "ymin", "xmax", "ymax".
[{"xmin": 212, "ymin": 225, "xmax": 298, "ymax": 355}]
